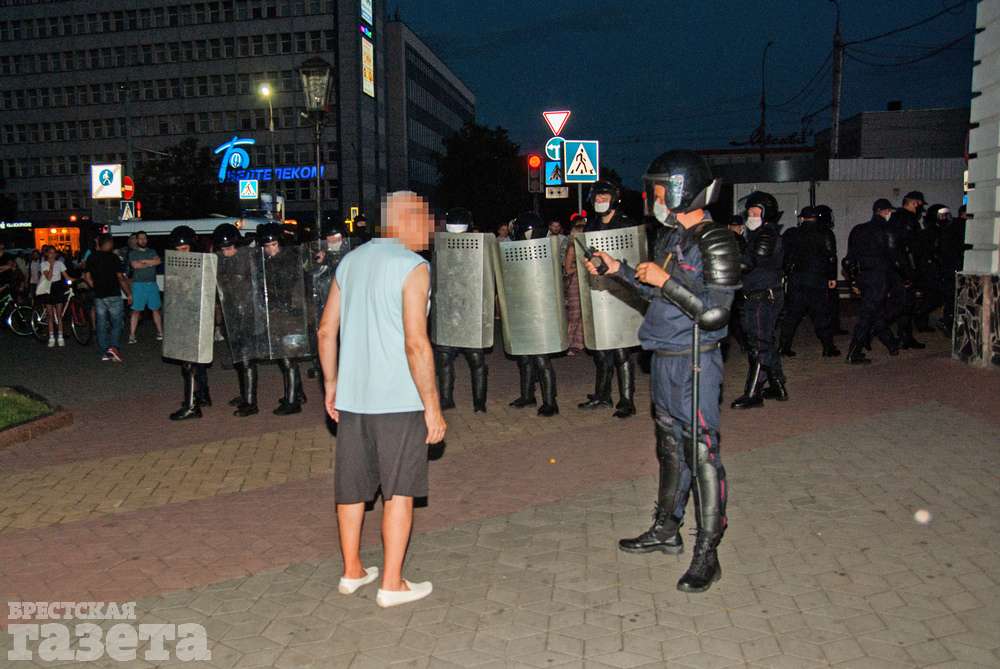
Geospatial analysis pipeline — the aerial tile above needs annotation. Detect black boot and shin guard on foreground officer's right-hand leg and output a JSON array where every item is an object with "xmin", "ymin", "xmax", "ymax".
[{"xmin": 677, "ymin": 442, "xmax": 726, "ymax": 593}]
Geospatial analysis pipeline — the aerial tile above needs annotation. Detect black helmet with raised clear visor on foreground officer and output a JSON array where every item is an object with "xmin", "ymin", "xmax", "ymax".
[{"xmin": 642, "ymin": 150, "xmax": 721, "ymax": 223}]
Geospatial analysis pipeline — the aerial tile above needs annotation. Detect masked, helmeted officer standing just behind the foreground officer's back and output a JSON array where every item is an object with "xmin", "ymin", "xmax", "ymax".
[{"xmin": 732, "ymin": 191, "xmax": 788, "ymax": 409}]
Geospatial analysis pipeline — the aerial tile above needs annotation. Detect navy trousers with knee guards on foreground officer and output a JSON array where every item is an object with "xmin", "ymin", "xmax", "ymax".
[{"xmin": 651, "ymin": 346, "xmax": 728, "ymax": 542}]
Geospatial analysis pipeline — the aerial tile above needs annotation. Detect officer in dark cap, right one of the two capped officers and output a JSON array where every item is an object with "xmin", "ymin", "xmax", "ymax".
[{"xmin": 889, "ymin": 191, "xmax": 927, "ymax": 349}]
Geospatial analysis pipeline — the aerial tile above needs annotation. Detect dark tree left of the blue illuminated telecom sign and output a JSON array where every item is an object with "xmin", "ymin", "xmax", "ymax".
[{"xmin": 136, "ymin": 137, "xmax": 239, "ymax": 220}]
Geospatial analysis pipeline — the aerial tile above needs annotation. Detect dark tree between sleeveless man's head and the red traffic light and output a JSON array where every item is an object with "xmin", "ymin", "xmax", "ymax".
[{"xmin": 437, "ymin": 122, "xmax": 528, "ymax": 232}]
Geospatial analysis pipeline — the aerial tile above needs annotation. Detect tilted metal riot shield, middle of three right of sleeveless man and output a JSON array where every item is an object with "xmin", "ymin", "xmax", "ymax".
[{"xmin": 495, "ymin": 237, "xmax": 569, "ymax": 355}]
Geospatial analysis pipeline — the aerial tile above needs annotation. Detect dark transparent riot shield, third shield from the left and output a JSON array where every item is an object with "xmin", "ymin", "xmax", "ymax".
[{"xmin": 250, "ymin": 246, "xmax": 313, "ymax": 360}]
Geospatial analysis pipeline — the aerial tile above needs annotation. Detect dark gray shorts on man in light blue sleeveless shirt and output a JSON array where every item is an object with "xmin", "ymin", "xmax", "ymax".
[{"xmin": 334, "ymin": 411, "xmax": 427, "ymax": 504}]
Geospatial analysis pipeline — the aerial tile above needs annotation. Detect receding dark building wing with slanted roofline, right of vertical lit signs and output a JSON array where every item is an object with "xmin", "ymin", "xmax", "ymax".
[{"xmin": 385, "ymin": 18, "xmax": 476, "ymax": 197}]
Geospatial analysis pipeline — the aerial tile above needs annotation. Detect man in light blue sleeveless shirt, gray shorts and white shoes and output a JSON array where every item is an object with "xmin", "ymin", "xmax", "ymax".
[{"xmin": 318, "ymin": 192, "xmax": 447, "ymax": 607}]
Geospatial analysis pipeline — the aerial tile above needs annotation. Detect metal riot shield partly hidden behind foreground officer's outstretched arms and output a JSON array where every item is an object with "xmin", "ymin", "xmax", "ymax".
[{"xmin": 576, "ymin": 226, "xmax": 647, "ymax": 351}]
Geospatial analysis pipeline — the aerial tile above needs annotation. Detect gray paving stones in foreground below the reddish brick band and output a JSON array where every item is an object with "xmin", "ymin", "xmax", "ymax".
[{"xmin": 0, "ymin": 402, "xmax": 1000, "ymax": 669}]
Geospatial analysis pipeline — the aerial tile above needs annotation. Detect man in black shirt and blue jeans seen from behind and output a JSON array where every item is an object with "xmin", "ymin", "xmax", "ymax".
[{"xmin": 83, "ymin": 234, "xmax": 132, "ymax": 362}]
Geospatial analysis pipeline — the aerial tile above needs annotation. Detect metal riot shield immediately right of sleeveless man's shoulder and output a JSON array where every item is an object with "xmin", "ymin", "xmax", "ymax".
[{"xmin": 431, "ymin": 232, "xmax": 497, "ymax": 349}]
